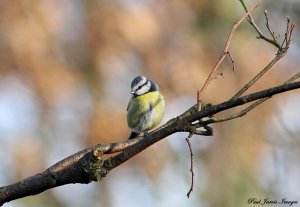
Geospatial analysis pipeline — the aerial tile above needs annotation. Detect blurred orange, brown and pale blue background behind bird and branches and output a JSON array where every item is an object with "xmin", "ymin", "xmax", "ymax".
[{"xmin": 0, "ymin": 0, "xmax": 300, "ymax": 207}]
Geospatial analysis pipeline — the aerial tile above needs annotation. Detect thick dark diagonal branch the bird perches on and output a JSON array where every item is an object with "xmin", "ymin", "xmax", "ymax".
[{"xmin": 0, "ymin": 81, "xmax": 300, "ymax": 205}]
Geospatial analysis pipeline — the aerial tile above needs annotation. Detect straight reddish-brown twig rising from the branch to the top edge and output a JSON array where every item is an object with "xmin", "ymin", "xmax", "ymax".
[{"xmin": 197, "ymin": 0, "xmax": 261, "ymax": 110}]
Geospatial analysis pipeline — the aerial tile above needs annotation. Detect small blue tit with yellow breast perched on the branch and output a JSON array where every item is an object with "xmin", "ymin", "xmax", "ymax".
[{"xmin": 127, "ymin": 76, "xmax": 165, "ymax": 139}]
